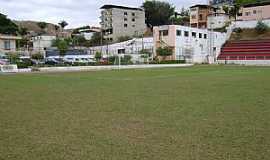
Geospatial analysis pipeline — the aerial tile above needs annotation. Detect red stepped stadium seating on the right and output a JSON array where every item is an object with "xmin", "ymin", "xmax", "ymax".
[{"xmin": 218, "ymin": 39, "xmax": 270, "ymax": 60}]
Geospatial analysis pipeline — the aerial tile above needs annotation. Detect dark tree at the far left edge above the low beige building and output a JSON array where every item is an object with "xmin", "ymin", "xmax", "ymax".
[{"xmin": 0, "ymin": 13, "xmax": 19, "ymax": 35}]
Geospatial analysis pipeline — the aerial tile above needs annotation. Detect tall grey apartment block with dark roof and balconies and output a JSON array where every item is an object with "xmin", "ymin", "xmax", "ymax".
[{"xmin": 100, "ymin": 5, "xmax": 146, "ymax": 41}]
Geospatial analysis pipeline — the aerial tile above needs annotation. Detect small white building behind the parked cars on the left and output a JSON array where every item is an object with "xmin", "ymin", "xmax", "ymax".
[{"xmin": 32, "ymin": 35, "xmax": 56, "ymax": 54}]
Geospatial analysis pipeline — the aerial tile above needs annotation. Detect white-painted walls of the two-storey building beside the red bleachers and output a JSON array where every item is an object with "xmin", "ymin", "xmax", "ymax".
[{"xmin": 156, "ymin": 26, "xmax": 226, "ymax": 63}]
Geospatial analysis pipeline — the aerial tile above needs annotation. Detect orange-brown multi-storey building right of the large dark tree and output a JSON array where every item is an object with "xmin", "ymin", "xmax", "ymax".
[{"xmin": 190, "ymin": 5, "xmax": 213, "ymax": 28}]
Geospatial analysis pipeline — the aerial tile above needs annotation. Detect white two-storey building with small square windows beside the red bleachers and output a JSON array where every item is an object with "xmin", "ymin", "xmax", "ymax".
[{"xmin": 153, "ymin": 25, "xmax": 226, "ymax": 63}]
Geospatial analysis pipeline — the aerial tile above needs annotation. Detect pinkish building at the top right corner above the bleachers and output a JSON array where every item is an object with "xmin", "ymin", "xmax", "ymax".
[{"xmin": 237, "ymin": 2, "xmax": 270, "ymax": 21}]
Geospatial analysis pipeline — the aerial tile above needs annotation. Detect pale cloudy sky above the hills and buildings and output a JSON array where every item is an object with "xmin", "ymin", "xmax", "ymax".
[{"xmin": 0, "ymin": 0, "xmax": 207, "ymax": 28}]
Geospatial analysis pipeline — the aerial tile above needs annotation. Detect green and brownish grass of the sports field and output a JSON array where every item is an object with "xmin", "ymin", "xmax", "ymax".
[{"xmin": 0, "ymin": 66, "xmax": 270, "ymax": 160}]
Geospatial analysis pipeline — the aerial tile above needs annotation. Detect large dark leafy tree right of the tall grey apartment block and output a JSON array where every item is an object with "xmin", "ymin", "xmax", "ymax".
[{"xmin": 142, "ymin": 0, "xmax": 175, "ymax": 27}]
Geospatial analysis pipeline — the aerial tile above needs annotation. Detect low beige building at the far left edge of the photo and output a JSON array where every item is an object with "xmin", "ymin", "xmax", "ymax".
[{"xmin": 0, "ymin": 34, "xmax": 21, "ymax": 53}]
